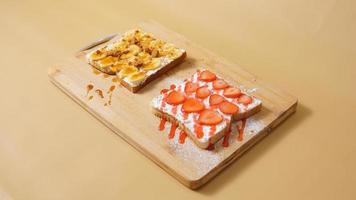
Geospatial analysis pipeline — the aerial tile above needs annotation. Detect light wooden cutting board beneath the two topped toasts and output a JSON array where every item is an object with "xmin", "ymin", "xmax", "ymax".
[{"xmin": 49, "ymin": 22, "xmax": 297, "ymax": 189}]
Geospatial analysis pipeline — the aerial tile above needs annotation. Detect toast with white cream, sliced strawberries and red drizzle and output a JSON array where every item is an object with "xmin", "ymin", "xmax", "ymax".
[{"xmin": 151, "ymin": 69, "xmax": 262, "ymax": 149}]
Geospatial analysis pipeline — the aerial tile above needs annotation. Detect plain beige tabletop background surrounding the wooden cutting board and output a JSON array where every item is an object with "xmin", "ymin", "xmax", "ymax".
[{"xmin": 0, "ymin": 0, "xmax": 356, "ymax": 199}]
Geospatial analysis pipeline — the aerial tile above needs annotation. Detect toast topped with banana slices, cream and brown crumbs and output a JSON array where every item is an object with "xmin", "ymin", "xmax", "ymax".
[{"xmin": 86, "ymin": 29, "xmax": 186, "ymax": 93}]
